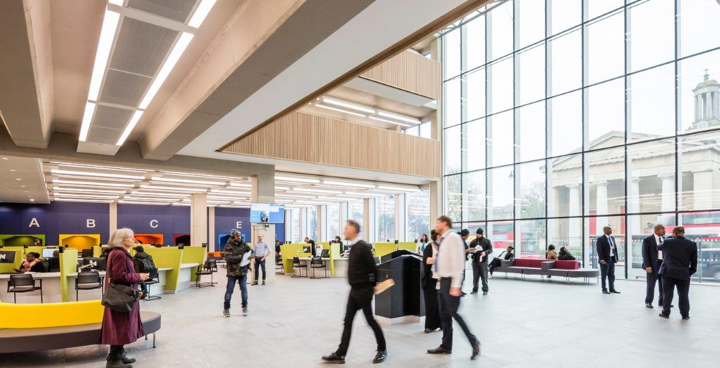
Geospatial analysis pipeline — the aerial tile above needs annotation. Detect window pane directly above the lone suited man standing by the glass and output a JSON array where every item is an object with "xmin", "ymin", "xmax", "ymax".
[{"xmin": 585, "ymin": 148, "xmax": 625, "ymax": 217}]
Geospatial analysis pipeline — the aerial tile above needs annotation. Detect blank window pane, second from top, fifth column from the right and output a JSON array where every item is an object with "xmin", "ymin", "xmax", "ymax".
[{"xmin": 515, "ymin": 44, "xmax": 545, "ymax": 105}]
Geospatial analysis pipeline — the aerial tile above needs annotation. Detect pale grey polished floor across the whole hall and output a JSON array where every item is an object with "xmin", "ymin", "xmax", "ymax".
[{"xmin": 0, "ymin": 268, "xmax": 720, "ymax": 368}]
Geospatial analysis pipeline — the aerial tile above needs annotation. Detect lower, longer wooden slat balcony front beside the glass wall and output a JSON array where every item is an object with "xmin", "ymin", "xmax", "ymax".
[{"xmin": 223, "ymin": 112, "xmax": 441, "ymax": 177}]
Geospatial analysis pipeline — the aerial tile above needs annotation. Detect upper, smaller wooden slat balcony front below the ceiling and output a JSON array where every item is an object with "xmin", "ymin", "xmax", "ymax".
[{"xmin": 360, "ymin": 50, "xmax": 442, "ymax": 100}]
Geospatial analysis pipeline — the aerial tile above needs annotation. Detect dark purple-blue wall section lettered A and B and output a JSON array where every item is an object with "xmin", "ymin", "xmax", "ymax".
[{"xmin": 0, "ymin": 202, "xmax": 110, "ymax": 245}]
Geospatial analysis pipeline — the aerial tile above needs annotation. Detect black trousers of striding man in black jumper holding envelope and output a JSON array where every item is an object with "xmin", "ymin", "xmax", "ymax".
[{"xmin": 335, "ymin": 286, "xmax": 387, "ymax": 356}]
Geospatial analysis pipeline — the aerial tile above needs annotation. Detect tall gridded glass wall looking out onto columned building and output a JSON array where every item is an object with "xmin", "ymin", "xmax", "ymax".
[{"xmin": 442, "ymin": 0, "xmax": 720, "ymax": 283}]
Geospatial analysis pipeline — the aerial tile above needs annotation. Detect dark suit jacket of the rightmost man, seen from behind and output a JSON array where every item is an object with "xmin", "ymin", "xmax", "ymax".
[{"xmin": 658, "ymin": 237, "xmax": 697, "ymax": 280}]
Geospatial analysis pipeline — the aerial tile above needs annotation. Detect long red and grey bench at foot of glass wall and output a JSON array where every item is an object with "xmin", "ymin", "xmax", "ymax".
[{"xmin": 494, "ymin": 258, "xmax": 600, "ymax": 283}]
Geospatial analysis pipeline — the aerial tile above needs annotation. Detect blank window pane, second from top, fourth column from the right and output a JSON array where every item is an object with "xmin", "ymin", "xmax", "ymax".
[{"xmin": 547, "ymin": 30, "xmax": 582, "ymax": 96}]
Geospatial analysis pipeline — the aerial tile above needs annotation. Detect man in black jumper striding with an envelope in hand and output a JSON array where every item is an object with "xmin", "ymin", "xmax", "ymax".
[{"xmin": 323, "ymin": 220, "xmax": 387, "ymax": 364}]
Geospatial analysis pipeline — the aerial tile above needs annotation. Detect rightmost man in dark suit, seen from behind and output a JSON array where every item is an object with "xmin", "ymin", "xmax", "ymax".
[{"xmin": 658, "ymin": 226, "xmax": 697, "ymax": 320}]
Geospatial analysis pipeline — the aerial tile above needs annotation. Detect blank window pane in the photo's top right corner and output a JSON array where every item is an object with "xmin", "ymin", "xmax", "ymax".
[{"xmin": 678, "ymin": 0, "xmax": 720, "ymax": 57}]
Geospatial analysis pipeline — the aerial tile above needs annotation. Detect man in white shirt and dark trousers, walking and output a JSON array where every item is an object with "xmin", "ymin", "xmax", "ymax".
[{"xmin": 428, "ymin": 216, "xmax": 480, "ymax": 360}]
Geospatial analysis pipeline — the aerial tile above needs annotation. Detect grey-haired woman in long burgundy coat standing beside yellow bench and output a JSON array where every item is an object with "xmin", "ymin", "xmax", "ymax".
[{"xmin": 100, "ymin": 228, "xmax": 148, "ymax": 368}]
